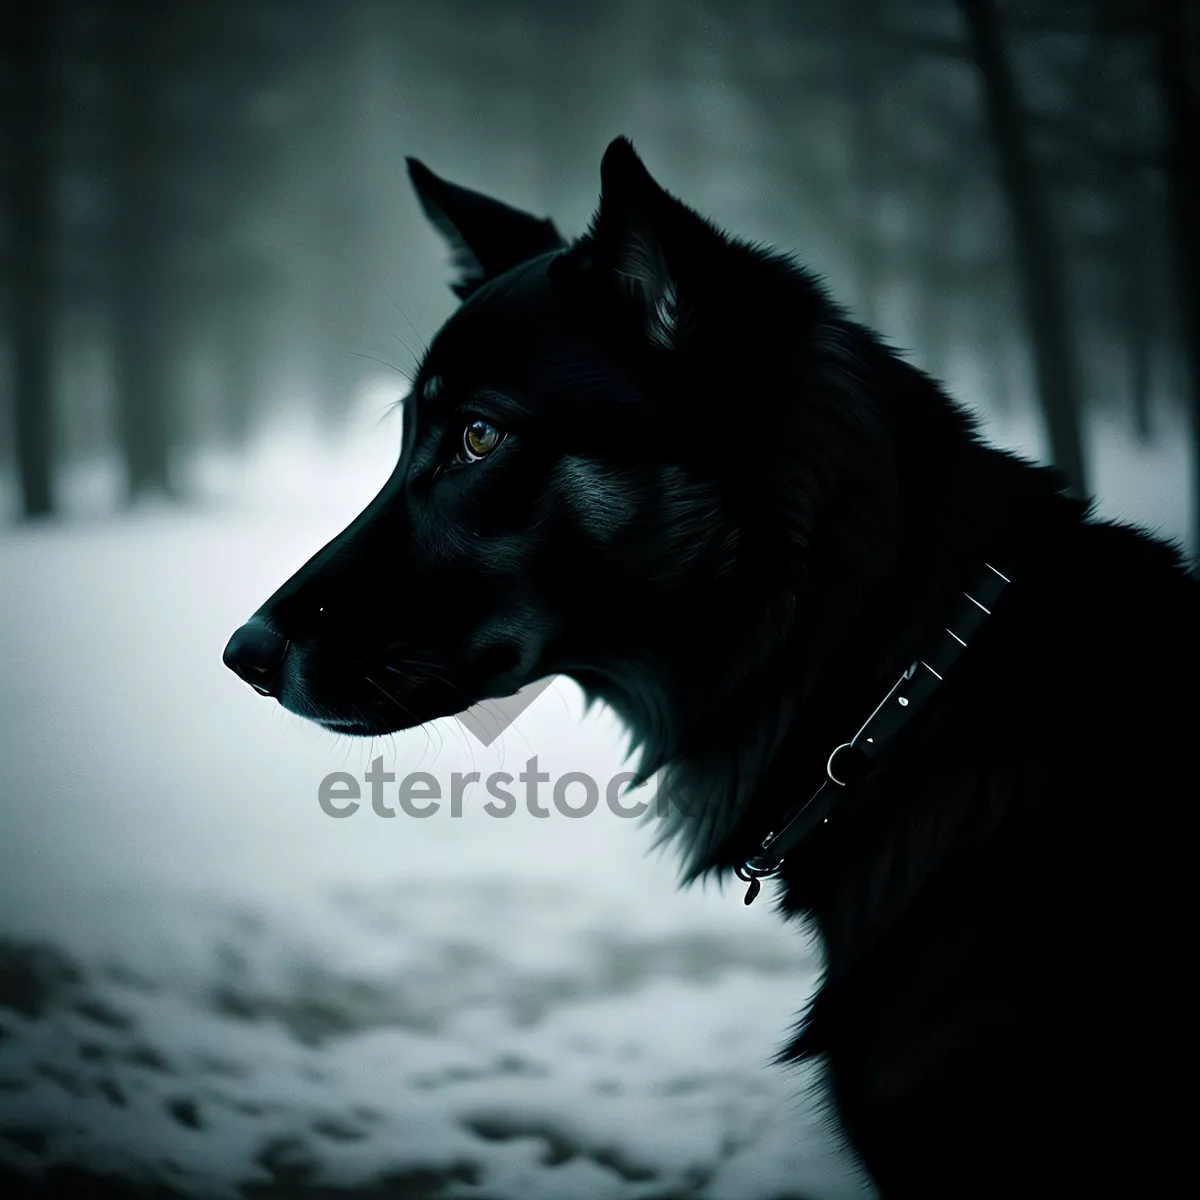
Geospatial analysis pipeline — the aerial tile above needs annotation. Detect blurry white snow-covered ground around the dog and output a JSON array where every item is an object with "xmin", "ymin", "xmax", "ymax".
[{"xmin": 0, "ymin": 388, "xmax": 1187, "ymax": 1200}]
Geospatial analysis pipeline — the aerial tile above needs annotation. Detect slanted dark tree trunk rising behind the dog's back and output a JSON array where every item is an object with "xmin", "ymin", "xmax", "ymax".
[{"xmin": 958, "ymin": 0, "xmax": 1087, "ymax": 493}]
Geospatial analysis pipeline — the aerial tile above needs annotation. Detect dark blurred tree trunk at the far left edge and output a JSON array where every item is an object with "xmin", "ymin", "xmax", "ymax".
[{"xmin": 4, "ymin": 0, "xmax": 56, "ymax": 517}]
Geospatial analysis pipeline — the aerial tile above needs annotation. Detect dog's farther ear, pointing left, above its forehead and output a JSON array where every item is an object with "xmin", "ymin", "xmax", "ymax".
[{"xmin": 406, "ymin": 158, "xmax": 564, "ymax": 300}]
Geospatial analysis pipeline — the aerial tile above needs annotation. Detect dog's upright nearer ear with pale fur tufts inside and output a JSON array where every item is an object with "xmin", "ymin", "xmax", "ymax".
[{"xmin": 590, "ymin": 138, "xmax": 696, "ymax": 349}]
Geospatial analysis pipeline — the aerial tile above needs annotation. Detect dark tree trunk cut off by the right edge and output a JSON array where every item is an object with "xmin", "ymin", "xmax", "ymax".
[{"xmin": 1158, "ymin": 0, "xmax": 1200, "ymax": 563}]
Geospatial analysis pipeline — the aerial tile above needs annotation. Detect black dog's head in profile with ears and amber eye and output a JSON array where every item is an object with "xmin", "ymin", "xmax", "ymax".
[{"xmin": 226, "ymin": 139, "xmax": 893, "ymax": 740}]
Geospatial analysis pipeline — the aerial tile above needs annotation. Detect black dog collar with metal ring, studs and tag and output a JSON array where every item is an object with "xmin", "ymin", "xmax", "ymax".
[{"xmin": 736, "ymin": 563, "xmax": 1012, "ymax": 904}]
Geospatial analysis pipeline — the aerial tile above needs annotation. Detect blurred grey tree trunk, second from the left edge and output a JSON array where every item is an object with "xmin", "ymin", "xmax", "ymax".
[{"xmin": 110, "ymin": 4, "xmax": 174, "ymax": 500}]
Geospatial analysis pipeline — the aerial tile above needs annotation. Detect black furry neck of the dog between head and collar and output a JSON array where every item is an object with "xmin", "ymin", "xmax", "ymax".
[{"xmin": 585, "ymin": 328, "xmax": 1085, "ymax": 880}]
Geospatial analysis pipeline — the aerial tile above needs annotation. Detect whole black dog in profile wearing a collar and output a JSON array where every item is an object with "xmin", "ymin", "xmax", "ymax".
[{"xmin": 226, "ymin": 139, "xmax": 1200, "ymax": 1198}]
